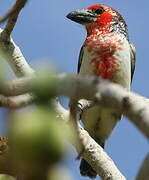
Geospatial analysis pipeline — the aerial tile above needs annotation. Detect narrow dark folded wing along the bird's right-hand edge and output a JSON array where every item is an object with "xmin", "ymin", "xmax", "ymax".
[{"xmin": 130, "ymin": 43, "xmax": 136, "ymax": 82}]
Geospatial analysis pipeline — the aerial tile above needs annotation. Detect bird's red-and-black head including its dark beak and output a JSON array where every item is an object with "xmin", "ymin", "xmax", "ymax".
[{"xmin": 67, "ymin": 5, "xmax": 127, "ymax": 34}]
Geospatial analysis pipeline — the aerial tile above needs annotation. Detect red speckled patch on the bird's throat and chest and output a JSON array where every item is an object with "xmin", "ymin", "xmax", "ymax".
[{"xmin": 84, "ymin": 29, "xmax": 123, "ymax": 80}]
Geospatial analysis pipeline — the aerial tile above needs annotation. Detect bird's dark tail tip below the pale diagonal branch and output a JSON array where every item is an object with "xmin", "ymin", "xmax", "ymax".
[{"xmin": 80, "ymin": 159, "xmax": 97, "ymax": 179}]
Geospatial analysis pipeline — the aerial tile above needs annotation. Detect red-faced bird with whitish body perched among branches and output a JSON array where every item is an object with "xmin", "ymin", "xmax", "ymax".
[{"xmin": 66, "ymin": 4, "xmax": 136, "ymax": 178}]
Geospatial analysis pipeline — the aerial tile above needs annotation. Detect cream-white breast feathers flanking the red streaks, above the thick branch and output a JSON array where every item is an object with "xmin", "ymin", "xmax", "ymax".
[{"xmin": 79, "ymin": 33, "xmax": 131, "ymax": 89}]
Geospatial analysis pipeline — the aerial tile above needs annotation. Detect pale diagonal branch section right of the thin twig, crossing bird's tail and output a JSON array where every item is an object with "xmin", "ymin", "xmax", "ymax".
[{"xmin": 76, "ymin": 128, "xmax": 125, "ymax": 180}]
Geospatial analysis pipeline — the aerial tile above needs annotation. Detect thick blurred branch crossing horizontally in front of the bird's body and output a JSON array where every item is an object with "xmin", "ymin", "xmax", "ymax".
[{"xmin": 0, "ymin": 75, "xmax": 149, "ymax": 138}]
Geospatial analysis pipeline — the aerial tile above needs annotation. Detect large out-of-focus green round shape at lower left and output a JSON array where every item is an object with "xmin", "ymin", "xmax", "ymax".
[{"xmin": 9, "ymin": 106, "xmax": 70, "ymax": 176}]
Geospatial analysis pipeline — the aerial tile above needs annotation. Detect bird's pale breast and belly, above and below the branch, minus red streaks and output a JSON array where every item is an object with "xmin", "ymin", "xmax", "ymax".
[{"xmin": 79, "ymin": 36, "xmax": 131, "ymax": 143}]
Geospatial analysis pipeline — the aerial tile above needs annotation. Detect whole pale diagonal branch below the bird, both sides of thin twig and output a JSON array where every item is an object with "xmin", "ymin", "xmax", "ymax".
[{"xmin": 55, "ymin": 102, "xmax": 125, "ymax": 180}]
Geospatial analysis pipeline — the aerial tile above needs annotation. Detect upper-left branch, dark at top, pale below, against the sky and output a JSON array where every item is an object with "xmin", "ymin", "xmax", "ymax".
[{"xmin": 0, "ymin": 0, "xmax": 34, "ymax": 77}]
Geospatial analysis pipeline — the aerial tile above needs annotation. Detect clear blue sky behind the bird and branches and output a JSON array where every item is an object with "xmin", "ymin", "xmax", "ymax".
[{"xmin": 0, "ymin": 0, "xmax": 149, "ymax": 180}]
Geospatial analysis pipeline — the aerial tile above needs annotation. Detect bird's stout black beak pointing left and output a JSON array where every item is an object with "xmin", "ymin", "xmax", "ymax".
[{"xmin": 66, "ymin": 9, "xmax": 97, "ymax": 25}]
